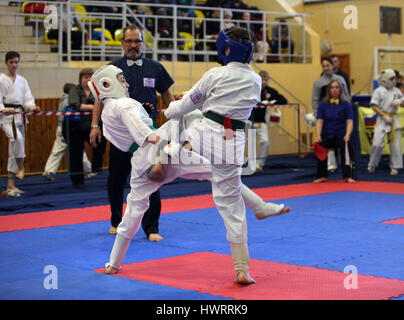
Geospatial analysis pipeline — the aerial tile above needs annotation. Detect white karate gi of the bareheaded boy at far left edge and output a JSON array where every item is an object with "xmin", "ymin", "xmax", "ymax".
[{"xmin": 0, "ymin": 73, "xmax": 35, "ymax": 173}]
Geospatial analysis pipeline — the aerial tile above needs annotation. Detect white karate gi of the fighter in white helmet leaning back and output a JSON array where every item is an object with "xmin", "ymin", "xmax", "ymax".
[{"xmin": 101, "ymin": 98, "xmax": 278, "ymax": 269}]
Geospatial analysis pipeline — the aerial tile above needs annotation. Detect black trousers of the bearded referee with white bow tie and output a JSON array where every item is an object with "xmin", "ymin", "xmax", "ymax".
[{"xmin": 107, "ymin": 143, "xmax": 161, "ymax": 237}]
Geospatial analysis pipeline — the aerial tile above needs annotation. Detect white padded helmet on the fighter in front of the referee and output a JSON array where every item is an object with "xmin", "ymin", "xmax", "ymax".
[{"xmin": 88, "ymin": 65, "xmax": 127, "ymax": 101}]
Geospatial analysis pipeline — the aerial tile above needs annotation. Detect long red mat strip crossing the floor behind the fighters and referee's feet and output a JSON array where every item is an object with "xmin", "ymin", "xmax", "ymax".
[{"xmin": 0, "ymin": 181, "xmax": 404, "ymax": 232}]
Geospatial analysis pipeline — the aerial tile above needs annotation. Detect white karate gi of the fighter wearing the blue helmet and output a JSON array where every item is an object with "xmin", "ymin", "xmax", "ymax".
[{"xmin": 165, "ymin": 62, "xmax": 261, "ymax": 243}]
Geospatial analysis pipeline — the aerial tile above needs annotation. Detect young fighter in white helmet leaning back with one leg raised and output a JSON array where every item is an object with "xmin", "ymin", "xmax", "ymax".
[{"xmin": 89, "ymin": 65, "xmax": 289, "ymax": 284}]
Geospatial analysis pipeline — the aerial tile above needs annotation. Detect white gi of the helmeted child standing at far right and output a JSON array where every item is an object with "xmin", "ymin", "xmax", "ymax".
[{"xmin": 368, "ymin": 86, "xmax": 404, "ymax": 169}]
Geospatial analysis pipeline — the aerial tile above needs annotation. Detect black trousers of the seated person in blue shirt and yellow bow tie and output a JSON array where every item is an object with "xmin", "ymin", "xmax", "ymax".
[{"xmin": 317, "ymin": 137, "xmax": 353, "ymax": 179}]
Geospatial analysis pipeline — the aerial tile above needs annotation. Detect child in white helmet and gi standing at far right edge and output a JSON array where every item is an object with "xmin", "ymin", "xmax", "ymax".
[{"xmin": 368, "ymin": 69, "xmax": 404, "ymax": 175}]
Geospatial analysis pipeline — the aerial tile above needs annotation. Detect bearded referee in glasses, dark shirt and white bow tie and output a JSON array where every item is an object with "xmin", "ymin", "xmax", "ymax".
[{"xmin": 90, "ymin": 25, "xmax": 174, "ymax": 241}]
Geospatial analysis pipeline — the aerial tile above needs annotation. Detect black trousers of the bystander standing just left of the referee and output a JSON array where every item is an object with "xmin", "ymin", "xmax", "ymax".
[{"xmin": 62, "ymin": 118, "xmax": 106, "ymax": 186}]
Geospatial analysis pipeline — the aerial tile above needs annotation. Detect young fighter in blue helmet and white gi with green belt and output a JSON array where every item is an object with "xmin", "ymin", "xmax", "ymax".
[{"xmin": 164, "ymin": 28, "xmax": 287, "ymax": 284}]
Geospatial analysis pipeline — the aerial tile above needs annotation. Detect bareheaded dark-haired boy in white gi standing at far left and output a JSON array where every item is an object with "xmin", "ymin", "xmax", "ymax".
[{"xmin": 0, "ymin": 51, "xmax": 40, "ymax": 196}]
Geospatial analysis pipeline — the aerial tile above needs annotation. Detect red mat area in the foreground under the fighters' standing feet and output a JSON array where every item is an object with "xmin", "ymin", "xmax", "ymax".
[{"xmin": 95, "ymin": 252, "xmax": 404, "ymax": 300}]
